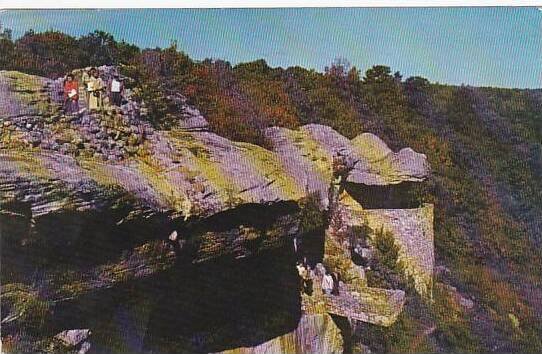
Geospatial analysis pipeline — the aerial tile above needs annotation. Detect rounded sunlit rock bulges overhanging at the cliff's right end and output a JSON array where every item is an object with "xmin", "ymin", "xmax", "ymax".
[{"xmin": 266, "ymin": 124, "xmax": 430, "ymax": 191}]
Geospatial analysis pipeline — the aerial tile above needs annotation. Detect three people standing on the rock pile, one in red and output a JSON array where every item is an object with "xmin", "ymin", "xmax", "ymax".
[{"xmin": 64, "ymin": 68, "xmax": 124, "ymax": 114}]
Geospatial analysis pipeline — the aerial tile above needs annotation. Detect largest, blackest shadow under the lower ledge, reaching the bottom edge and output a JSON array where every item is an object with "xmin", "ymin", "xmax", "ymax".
[{"xmin": 48, "ymin": 248, "xmax": 301, "ymax": 353}]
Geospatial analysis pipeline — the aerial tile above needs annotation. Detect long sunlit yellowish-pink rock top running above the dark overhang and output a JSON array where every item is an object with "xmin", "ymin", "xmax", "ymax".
[{"xmin": 0, "ymin": 71, "xmax": 429, "ymax": 218}]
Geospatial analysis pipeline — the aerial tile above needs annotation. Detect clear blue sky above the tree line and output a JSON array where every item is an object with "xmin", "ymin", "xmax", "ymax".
[{"xmin": 0, "ymin": 7, "xmax": 542, "ymax": 88}]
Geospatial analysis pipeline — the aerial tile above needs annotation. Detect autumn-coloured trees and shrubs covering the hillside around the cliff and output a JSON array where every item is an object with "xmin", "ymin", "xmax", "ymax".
[{"xmin": 4, "ymin": 28, "xmax": 542, "ymax": 351}]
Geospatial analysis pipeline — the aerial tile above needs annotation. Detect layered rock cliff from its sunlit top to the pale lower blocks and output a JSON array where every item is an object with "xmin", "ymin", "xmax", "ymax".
[{"xmin": 0, "ymin": 68, "xmax": 433, "ymax": 352}]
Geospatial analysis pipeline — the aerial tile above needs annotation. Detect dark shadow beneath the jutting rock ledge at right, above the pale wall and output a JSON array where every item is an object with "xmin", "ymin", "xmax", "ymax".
[{"xmin": 345, "ymin": 182, "xmax": 423, "ymax": 209}]
